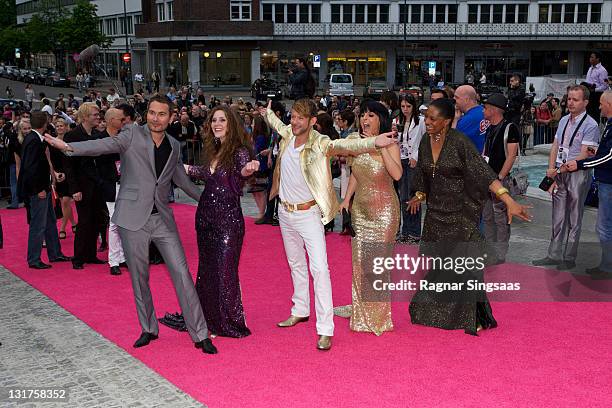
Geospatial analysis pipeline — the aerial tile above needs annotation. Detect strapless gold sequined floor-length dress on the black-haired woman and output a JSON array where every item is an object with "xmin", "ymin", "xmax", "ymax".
[{"xmin": 350, "ymin": 153, "xmax": 400, "ymax": 335}]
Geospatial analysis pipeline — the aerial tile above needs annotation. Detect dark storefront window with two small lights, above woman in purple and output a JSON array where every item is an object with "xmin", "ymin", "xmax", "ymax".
[{"xmin": 200, "ymin": 50, "xmax": 251, "ymax": 87}]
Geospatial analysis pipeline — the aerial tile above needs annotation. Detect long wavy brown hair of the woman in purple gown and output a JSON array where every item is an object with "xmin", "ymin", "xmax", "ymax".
[{"xmin": 202, "ymin": 105, "xmax": 253, "ymax": 170}]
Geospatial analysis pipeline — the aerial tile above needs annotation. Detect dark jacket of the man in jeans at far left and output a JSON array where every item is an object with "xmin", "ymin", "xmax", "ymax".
[{"xmin": 17, "ymin": 131, "xmax": 51, "ymax": 200}]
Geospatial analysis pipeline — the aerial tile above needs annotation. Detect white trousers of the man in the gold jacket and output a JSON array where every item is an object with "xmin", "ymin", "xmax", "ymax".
[{"xmin": 278, "ymin": 205, "xmax": 334, "ymax": 336}]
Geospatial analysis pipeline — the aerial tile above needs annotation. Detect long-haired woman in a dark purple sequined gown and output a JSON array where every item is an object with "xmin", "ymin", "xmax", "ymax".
[{"xmin": 185, "ymin": 107, "xmax": 259, "ymax": 337}]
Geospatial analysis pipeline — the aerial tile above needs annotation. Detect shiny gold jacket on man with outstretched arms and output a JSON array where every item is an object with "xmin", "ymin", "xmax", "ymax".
[{"xmin": 266, "ymin": 109, "xmax": 376, "ymax": 224}]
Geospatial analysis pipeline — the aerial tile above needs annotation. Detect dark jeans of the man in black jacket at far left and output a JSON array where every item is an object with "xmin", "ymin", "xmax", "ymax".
[{"xmin": 28, "ymin": 193, "xmax": 62, "ymax": 265}]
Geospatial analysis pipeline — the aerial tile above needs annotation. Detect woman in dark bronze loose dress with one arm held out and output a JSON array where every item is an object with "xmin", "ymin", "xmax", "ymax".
[{"xmin": 408, "ymin": 99, "xmax": 529, "ymax": 335}]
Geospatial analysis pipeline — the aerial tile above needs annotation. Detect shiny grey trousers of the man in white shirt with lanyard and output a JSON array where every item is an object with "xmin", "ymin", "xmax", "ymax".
[{"xmin": 548, "ymin": 170, "xmax": 591, "ymax": 261}]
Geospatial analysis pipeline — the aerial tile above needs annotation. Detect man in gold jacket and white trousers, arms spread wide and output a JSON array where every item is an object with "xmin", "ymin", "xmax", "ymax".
[{"xmin": 261, "ymin": 99, "xmax": 396, "ymax": 350}]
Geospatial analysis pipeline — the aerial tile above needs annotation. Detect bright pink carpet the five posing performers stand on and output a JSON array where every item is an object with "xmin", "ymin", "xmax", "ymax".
[{"xmin": 0, "ymin": 205, "xmax": 612, "ymax": 408}]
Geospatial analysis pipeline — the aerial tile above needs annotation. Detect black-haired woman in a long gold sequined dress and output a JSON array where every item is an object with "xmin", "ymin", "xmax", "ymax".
[{"xmin": 339, "ymin": 101, "xmax": 402, "ymax": 335}]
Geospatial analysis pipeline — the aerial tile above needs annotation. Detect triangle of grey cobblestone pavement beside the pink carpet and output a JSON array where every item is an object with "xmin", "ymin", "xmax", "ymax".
[{"xmin": 0, "ymin": 267, "xmax": 203, "ymax": 408}]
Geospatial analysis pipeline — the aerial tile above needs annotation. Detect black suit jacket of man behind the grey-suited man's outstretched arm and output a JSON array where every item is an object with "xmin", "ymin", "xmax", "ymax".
[{"xmin": 64, "ymin": 125, "xmax": 102, "ymax": 197}]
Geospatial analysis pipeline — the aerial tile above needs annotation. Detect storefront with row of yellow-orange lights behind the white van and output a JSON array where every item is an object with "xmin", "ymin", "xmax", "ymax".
[{"xmin": 327, "ymin": 51, "xmax": 387, "ymax": 86}]
